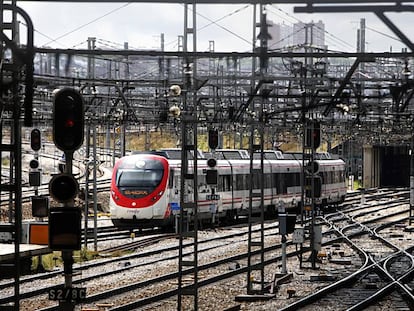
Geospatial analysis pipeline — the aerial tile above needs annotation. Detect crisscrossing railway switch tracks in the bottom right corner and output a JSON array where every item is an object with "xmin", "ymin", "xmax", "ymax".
[{"xmin": 282, "ymin": 197, "xmax": 414, "ymax": 310}]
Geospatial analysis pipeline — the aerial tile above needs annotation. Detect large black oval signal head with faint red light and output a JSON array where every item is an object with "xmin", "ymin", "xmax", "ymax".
[{"xmin": 53, "ymin": 88, "xmax": 84, "ymax": 153}]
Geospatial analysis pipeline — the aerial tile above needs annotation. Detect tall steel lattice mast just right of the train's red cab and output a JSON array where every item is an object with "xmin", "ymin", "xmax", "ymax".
[{"xmin": 177, "ymin": 1, "xmax": 198, "ymax": 311}]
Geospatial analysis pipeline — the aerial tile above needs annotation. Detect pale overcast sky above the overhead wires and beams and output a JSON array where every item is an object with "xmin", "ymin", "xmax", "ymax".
[{"xmin": 18, "ymin": 1, "xmax": 414, "ymax": 52}]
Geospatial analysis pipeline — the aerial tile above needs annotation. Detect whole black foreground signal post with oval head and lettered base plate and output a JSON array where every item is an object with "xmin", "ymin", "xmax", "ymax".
[{"xmin": 49, "ymin": 88, "xmax": 86, "ymax": 311}]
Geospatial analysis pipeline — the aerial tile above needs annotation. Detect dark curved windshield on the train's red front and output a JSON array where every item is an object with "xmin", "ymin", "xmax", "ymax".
[{"xmin": 116, "ymin": 161, "xmax": 164, "ymax": 198}]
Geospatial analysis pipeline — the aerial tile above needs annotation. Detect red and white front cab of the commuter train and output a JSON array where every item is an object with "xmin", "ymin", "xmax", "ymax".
[{"xmin": 110, "ymin": 155, "xmax": 170, "ymax": 228}]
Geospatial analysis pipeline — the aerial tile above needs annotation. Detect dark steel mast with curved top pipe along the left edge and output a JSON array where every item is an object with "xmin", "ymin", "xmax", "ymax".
[{"xmin": 0, "ymin": 0, "xmax": 34, "ymax": 310}]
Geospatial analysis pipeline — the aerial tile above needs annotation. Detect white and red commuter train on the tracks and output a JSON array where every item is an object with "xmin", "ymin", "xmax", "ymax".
[{"xmin": 110, "ymin": 149, "xmax": 346, "ymax": 228}]
